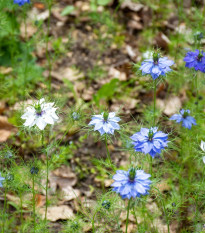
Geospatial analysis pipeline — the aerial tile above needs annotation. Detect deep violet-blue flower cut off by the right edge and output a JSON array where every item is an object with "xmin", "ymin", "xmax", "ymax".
[{"xmin": 184, "ymin": 49, "xmax": 205, "ymax": 73}]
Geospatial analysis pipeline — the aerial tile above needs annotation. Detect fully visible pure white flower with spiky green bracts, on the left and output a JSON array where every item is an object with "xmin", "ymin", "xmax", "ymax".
[{"xmin": 21, "ymin": 98, "xmax": 59, "ymax": 130}]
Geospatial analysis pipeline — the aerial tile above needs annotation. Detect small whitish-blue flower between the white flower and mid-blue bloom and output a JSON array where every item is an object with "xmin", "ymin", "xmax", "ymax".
[{"xmin": 89, "ymin": 112, "xmax": 120, "ymax": 135}]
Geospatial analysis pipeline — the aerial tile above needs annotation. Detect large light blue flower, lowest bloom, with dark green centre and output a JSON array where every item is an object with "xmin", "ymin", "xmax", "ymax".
[{"xmin": 111, "ymin": 168, "xmax": 151, "ymax": 199}]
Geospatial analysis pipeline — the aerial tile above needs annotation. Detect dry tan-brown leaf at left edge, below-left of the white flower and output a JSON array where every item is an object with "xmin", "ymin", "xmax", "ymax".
[{"xmin": 0, "ymin": 116, "xmax": 16, "ymax": 142}]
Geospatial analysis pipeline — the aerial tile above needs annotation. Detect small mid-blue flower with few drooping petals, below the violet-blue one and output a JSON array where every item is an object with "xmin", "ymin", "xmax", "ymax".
[{"xmin": 169, "ymin": 109, "xmax": 196, "ymax": 129}]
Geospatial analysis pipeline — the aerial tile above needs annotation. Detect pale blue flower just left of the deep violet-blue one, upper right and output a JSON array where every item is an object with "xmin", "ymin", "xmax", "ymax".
[{"xmin": 140, "ymin": 53, "xmax": 174, "ymax": 80}]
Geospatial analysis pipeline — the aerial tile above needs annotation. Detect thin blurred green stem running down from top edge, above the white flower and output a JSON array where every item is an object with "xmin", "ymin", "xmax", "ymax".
[{"xmin": 46, "ymin": 0, "xmax": 52, "ymax": 92}]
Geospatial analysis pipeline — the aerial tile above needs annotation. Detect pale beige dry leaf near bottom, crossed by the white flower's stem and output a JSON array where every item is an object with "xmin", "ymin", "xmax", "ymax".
[{"xmin": 38, "ymin": 205, "xmax": 74, "ymax": 222}]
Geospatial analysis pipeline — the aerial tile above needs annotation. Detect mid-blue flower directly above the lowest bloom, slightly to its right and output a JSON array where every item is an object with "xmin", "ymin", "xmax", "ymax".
[{"xmin": 130, "ymin": 127, "xmax": 168, "ymax": 158}]
